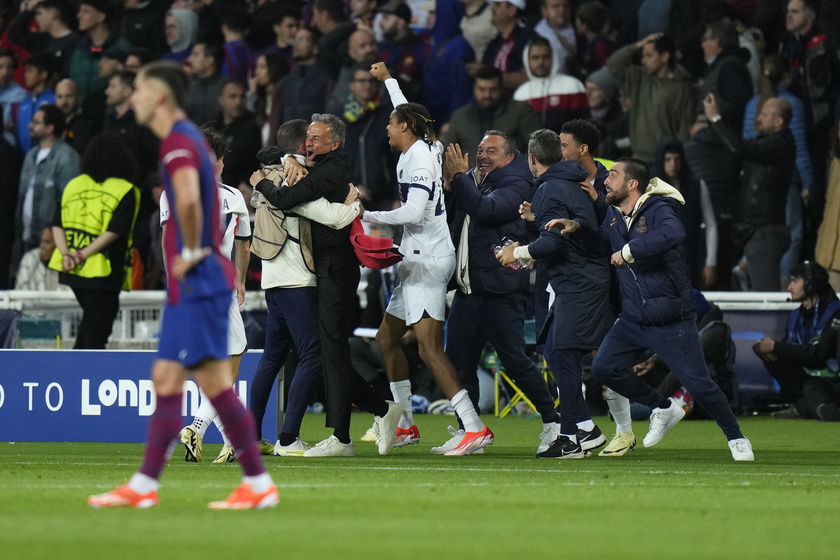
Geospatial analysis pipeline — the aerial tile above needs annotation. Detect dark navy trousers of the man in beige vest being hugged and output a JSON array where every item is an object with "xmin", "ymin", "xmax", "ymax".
[{"xmin": 251, "ymin": 287, "xmax": 322, "ymax": 437}]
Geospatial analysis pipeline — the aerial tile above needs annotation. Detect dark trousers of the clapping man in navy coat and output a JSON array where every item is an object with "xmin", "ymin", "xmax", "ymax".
[{"xmin": 446, "ymin": 292, "xmax": 556, "ymax": 422}]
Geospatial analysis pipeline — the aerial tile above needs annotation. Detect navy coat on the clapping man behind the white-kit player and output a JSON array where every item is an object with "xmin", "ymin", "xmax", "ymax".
[{"xmin": 446, "ymin": 151, "xmax": 534, "ymax": 295}]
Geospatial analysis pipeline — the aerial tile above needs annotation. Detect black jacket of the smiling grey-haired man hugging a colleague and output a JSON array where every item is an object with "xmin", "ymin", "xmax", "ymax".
[{"xmin": 257, "ymin": 151, "xmax": 353, "ymax": 259}]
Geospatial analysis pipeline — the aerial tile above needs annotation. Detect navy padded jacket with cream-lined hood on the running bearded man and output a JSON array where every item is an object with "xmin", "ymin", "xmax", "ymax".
[{"xmin": 600, "ymin": 178, "xmax": 695, "ymax": 326}]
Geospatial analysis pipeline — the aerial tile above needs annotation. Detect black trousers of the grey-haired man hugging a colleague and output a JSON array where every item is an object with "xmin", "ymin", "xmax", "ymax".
[{"xmin": 315, "ymin": 252, "xmax": 388, "ymax": 433}]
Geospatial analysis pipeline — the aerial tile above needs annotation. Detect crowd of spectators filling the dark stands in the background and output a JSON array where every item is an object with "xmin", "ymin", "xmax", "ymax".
[{"xmin": 0, "ymin": 0, "xmax": 840, "ymax": 291}]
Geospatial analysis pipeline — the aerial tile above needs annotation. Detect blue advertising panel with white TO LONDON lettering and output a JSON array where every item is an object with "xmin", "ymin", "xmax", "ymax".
[{"xmin": 0, "ymin": 350, "xmax": 277, "ymax": 443}]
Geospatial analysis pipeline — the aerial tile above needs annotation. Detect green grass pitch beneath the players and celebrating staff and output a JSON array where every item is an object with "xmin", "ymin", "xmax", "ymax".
[{"xmin": 0, "ymin": 414, "xmax": 840, "ymax": 560}]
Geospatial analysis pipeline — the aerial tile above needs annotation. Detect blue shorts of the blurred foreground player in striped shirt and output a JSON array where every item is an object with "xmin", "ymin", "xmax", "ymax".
[{"xmin": 158, "ymin": 292, "xmax": 230, "ymax": 368}]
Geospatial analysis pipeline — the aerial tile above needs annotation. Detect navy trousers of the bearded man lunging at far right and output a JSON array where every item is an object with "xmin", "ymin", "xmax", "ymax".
[{"xmin": 592, "ymin": 318, "xmax": 743, "ymax": 440}]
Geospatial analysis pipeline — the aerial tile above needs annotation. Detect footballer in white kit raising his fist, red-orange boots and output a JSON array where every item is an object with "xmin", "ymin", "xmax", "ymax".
[{"xmin": 362, "ymin": 62, "xmax": 493, "ymax": 455}]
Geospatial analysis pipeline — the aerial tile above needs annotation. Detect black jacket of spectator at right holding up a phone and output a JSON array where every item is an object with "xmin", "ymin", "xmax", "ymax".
[{"xmin": 712, "ymin": 120, "xmax": 796, "ymax": 227}]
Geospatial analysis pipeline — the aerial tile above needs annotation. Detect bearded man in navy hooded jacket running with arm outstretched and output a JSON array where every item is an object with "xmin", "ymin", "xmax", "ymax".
[{"xmin": 546, "ymin": 158, "xmax": 755, "ymax": 461}]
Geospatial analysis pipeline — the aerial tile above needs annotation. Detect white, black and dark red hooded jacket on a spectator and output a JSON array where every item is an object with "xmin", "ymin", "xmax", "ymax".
[{"xmin": 513, "ymin": 42, "xmax": 590, "ymax": 133}]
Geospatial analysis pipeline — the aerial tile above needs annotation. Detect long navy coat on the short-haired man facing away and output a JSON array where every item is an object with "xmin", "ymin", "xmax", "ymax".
[{"xmin": 528, "ymin": 161, "xmax": 613, "ymax": 350}]
